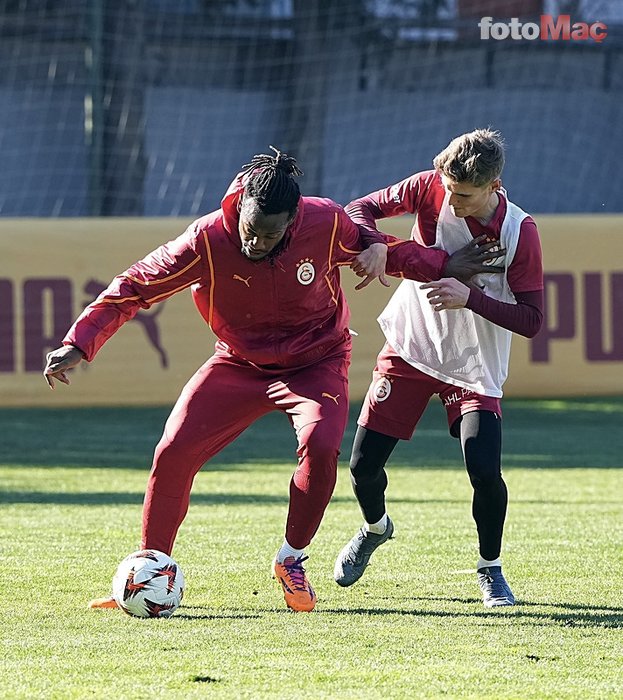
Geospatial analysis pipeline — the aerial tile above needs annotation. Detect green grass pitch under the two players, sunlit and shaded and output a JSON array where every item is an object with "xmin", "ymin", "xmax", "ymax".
[{"xmin": 0, "ymin": 398, "xmax": 623, "ymax": 700}]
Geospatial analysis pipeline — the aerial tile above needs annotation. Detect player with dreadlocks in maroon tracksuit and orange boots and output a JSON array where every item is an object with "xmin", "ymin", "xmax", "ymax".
[{"xmin": 44, "ymin": 149, "xmax": 502, "ymax": 611}]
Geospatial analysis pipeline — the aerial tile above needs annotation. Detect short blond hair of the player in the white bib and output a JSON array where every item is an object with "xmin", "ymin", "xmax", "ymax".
[{"xmin": 433, "ymin": 129, "xmax": 504, "ymax": 187}]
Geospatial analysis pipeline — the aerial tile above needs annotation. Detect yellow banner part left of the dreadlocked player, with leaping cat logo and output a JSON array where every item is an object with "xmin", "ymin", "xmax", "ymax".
[{"xmin": 0, "ymin": 218, "xmax": 214, "ymax": 406}]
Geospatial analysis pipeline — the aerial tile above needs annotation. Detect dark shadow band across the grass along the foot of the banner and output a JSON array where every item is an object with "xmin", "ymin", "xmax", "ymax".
[{"xmin": 0, "ymin": 397, "xmax": 623, "ymax": 469}]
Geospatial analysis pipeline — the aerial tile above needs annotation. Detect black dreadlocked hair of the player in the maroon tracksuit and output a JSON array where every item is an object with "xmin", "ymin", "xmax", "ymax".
[{"xmin": 242, "ymin": 146, "xmax": 303, "ymax": 214}]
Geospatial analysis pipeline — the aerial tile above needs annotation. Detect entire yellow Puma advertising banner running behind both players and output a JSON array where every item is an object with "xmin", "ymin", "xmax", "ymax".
[{"xmin": 0, "ymin": 215, "xmax": 623, "ymax": 406}]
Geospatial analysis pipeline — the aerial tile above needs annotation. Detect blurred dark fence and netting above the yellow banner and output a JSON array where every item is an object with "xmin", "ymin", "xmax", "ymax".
[{"xmin": 0, "ymin": 0, "xmax": 623, "ymax": 217}]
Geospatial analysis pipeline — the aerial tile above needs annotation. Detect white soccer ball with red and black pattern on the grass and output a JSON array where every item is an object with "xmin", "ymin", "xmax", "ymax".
[{"xmin": 112, "ymin": 549, "xmax": 184, "ymax": 617}]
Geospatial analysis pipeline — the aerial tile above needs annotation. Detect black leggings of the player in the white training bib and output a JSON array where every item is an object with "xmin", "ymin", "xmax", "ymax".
[{"xmin": 350, "ymin": 411, "xmax": 508, "ymax": 560}]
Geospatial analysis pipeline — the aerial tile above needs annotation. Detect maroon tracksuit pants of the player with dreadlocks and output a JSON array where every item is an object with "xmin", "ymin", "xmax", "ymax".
[{"xmin": 142, "ymin": 352, "xmax": 350, "ymax": 554}]
